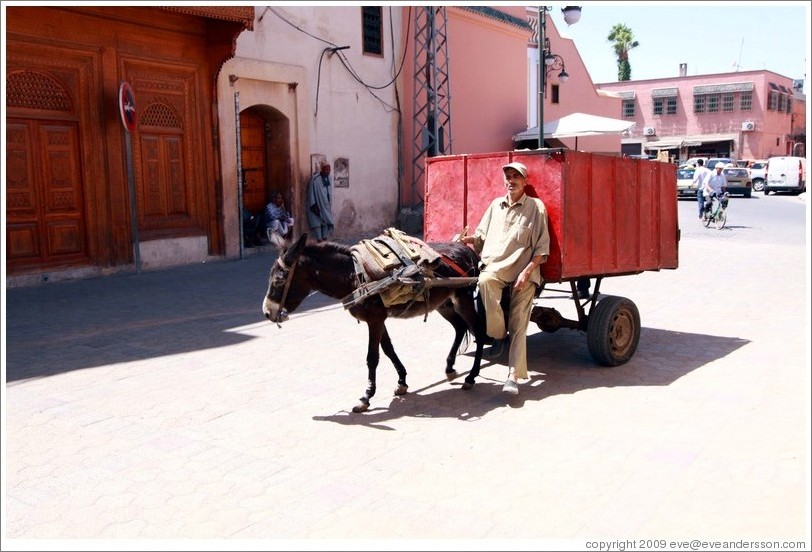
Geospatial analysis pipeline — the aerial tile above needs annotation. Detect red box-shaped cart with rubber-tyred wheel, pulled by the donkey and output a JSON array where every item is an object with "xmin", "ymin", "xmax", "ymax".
[{"xmin": 423, "ymin": 149, "xmax": 679, "ymax": 366}]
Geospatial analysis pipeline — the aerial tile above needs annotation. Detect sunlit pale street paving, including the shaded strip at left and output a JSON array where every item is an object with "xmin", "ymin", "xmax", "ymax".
[{"xmin": 2, "ymin": 197, "xmax": 810, "ymax": 550}]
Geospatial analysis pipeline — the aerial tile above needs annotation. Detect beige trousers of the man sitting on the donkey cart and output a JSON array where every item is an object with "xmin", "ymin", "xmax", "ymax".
[{"xmin": 478, "ymin": 272, "xmax": 536, "ymax": 379}]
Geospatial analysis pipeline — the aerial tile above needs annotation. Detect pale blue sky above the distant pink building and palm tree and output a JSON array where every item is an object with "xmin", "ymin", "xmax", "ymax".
[{"xmin": 550, "ymin": 1, "xmax": 812, "ymax": 90}]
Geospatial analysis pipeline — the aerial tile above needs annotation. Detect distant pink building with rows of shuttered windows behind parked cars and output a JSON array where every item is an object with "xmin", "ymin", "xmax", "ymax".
[{"xmin": 596, "ymin": 64, "xmax": 806, "ymax": 160}]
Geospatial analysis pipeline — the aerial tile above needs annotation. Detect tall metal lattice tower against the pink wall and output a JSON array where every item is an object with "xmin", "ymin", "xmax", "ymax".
[{"xmin": 412, "ymin": 6, "xmax": 451, "ymax": 205}]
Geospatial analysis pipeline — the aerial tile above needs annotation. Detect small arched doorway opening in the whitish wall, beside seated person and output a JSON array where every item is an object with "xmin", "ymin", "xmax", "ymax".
[{"xmin": 240, "ymin": 105, "xmax": 293, "ymax": 219}]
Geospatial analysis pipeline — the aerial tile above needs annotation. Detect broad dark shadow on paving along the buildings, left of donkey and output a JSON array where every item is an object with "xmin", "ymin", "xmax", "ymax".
[{"xmin": 6, "ymin": 252, "xmax": 334, "ymax": 382}]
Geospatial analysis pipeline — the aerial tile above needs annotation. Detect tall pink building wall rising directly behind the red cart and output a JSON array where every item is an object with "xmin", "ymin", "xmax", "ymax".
[{"xmin": 401, "ymin": 6, "xmax": 621, "ymax": 206}]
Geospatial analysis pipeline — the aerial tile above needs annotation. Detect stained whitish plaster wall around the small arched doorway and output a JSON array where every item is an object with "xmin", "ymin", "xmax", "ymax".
[{"xmin": 217, "ymin": 6, "xmax": 404, "ymax": 256}]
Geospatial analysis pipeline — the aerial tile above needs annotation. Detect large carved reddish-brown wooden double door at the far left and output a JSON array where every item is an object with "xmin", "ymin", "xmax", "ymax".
[{"xmin": 6, "ymin": 119, "xmax": 89, "ymax": 270}]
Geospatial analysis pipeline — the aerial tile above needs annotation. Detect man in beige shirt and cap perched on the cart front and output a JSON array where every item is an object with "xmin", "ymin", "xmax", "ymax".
[{"xmin": 459, "ymin": 163, "xmax": 550, "ymax": 395}]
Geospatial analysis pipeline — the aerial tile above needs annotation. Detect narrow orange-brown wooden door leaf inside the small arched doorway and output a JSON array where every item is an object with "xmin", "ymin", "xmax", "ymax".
[{"xmin": 240, "ymin": 110, "xmax": 270, "ymax": 215}]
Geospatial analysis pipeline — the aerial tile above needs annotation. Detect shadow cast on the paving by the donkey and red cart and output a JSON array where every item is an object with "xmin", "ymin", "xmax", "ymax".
[{"xmin": 313, "ymin": 328, "xmax": 749, "ymax": 430}]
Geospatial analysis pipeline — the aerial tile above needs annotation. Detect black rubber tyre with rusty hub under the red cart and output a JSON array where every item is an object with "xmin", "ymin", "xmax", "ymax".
[{"xmin": 586, "ymin": 295, "xmax": 640, "ymax": 366}]
